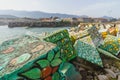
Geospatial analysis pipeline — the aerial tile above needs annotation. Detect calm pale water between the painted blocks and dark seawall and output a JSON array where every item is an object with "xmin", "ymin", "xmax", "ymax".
[{"xmin": 0, "ymin": 25, "xmax": 68, "ymax": 43}]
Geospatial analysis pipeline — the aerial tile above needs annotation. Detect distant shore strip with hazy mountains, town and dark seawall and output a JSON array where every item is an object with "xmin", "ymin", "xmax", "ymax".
[{"xmin": 0, "ymin": 10, "xmax": 120, "ymax": 27}]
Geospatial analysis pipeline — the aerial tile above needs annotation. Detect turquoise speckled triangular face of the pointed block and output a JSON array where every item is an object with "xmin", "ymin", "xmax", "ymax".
[{"xmin": 75, "ymin": 40, "xmax": 103, "ymax": 67}]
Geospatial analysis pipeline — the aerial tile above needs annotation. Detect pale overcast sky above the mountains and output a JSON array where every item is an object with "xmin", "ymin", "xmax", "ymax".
[{"xmin": 0, "ymin": 0, "xmax": 120, "ymax": 18}]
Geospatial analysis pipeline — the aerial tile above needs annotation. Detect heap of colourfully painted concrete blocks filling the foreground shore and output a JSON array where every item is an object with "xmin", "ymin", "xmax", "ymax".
[{"xmin": 0, "ymin": 25, "xmax": 120, "ymax": 80}]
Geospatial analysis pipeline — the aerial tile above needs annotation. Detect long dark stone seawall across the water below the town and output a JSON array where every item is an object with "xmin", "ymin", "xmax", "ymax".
[{"xmin": 8, "ymin": 21, "xmax": 79, "ymax": 27}]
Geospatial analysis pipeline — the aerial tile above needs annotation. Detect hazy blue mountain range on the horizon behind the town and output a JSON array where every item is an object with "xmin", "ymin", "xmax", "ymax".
[{"xmin": 0, "ymin": 10, "xmax": 80, "ymax": 18}]
